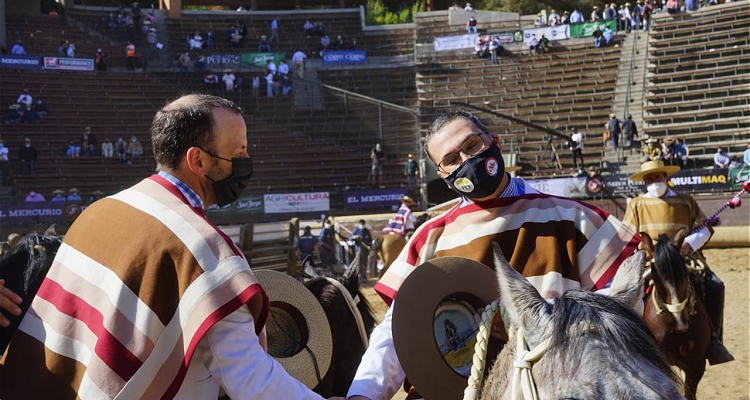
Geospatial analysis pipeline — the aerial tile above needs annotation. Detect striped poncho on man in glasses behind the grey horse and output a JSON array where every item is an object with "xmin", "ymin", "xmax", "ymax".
[{"xmin": 375, "ymin": 183, "xmax": 640, "ymax": 304}]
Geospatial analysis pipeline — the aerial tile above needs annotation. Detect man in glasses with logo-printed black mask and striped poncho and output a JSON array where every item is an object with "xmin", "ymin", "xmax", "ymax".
[{"xmin": 348, "ymin": 111, "xmax": 640, "ymax": 400}]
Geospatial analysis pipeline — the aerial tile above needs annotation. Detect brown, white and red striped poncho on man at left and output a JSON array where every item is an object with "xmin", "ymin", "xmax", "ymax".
[{"xmin": 0, "ymin": 175, "xmax": 268, "ymax": 400}]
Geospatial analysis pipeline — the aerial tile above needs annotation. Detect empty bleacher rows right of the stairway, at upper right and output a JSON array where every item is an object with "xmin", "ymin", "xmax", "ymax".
[{"xmin": 643, "ymin": 2, "xmax": 750, "ymax": 166}]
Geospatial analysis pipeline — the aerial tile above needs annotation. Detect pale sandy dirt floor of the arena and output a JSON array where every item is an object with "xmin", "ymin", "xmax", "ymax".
[{"xmin": 363, "ymin": 248, "xmax": 750, "ymax": 400}]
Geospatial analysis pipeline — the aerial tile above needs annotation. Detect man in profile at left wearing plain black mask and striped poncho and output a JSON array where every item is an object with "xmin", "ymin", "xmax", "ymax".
[{"xmin": 0, "ymin": 95, "xmax": 330, "ymax": 400}]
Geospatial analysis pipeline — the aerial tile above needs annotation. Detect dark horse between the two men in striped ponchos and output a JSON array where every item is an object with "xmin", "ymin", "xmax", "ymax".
[{"xmin": 300, "ymin": 251, "xmax": 375, "ymax": 398}]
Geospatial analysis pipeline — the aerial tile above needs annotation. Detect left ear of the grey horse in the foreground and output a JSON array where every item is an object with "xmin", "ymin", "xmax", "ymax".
[{"xmin": 492, "ymin": 242, "xmax": 552, "ymax": 341}]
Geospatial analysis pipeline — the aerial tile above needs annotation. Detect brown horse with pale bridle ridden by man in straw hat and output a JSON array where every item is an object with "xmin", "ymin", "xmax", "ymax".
[{"xmin": 641, "ymin": 230, "xmax": 711, "ymax": 399}]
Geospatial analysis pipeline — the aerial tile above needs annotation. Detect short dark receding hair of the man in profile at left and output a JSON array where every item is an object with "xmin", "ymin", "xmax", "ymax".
[{"xmin": 151, "ymin": 94, "xmax": 242, "ymax": 169}]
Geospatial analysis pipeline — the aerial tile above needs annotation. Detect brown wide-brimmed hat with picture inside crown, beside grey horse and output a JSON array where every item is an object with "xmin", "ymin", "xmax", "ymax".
[{"xmin": 392, "ymin": 257, "xmax": 500, "ymax": 400}]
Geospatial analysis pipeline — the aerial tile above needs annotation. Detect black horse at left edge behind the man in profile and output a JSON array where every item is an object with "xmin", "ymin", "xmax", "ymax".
[{"xmin": 0, "ymin": 225, "xmax": 62, "ymax": 354}]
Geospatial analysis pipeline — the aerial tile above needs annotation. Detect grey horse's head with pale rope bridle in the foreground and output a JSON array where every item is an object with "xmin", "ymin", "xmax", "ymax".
[{"xmin": 481, "ymin": 248, "xmax": 684, "ymax": 400}]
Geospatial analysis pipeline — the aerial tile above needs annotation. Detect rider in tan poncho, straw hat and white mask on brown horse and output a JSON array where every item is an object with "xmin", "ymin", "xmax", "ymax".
[{"xmin": 623, "ymin": 161, "xmax": 734, "ymax": 365}]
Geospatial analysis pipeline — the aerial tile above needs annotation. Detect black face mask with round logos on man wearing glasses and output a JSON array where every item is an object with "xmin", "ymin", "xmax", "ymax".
[{"xmin": 443, "ymin": 143, "xmax": 505, "ymax": 199}]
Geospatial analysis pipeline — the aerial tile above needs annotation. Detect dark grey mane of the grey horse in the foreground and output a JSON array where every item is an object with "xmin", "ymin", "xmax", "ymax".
[{"xmin": 548, "ymin": 290, "xmax": 679, "ymax": 392}]
